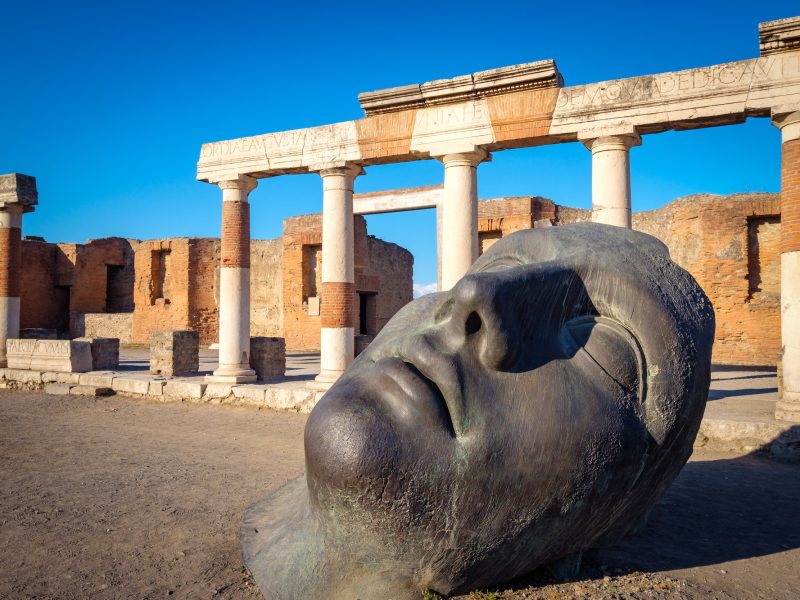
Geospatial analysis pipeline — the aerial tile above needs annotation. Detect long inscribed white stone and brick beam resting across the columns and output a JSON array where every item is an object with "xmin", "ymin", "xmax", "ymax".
[{"xmin": 197, "ymin": 19, "xmax": 800, "ymax": 182}]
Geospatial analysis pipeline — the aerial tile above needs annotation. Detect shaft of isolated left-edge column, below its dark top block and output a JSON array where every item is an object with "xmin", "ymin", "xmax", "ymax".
[{"xmin": 0, "ymin": 205, "xmax": 22, "ymax": 367}]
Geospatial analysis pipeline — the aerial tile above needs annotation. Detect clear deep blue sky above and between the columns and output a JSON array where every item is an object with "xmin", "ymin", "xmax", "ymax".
[{"xmin": 0, "ymin": 0, "xmax": 800, "ymax": 284}]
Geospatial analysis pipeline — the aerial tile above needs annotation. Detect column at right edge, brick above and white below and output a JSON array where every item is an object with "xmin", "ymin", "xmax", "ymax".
[{"xmin": 772, "ymin": 111, "xmax": 800, "ymax": 423}]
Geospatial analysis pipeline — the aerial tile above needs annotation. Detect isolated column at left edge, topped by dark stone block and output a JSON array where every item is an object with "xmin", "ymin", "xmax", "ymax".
[{"xmin": 0, "ymin": 173, "xmax": 38, "ymax": 367}]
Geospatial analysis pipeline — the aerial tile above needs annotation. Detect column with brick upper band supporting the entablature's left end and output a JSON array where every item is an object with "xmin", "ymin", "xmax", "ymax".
[{"xmin": 207, "ymin": 175, "xmax": 258, "ymax": 383}]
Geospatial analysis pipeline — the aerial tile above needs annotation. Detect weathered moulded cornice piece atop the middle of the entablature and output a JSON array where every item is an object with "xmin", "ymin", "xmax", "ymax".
[{"xmin": 358, "ymin": 59, "xmax": 564, "ymax": 117}]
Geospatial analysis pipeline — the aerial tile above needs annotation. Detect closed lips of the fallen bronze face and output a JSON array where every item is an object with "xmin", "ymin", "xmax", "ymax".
[{"xmin": 373, "ymin": 352, "xmax": 464, "ymax": 435}]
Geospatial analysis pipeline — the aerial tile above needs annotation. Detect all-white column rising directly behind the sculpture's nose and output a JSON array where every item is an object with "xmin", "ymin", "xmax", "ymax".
[{"xmin": 437, "ymin": 149, "xmax": 489, "ymax": 290}]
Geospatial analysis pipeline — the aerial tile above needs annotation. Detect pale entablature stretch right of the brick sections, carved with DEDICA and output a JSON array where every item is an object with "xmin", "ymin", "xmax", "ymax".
[{"xmin": 556, "ymin": 54, "xmax": 800, "ymax": 109}]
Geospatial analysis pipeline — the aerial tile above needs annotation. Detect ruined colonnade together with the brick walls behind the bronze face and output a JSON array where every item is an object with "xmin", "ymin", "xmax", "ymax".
[{"xmin": 0, "ymin": 18, "xmax": 800, "ymax": 421}]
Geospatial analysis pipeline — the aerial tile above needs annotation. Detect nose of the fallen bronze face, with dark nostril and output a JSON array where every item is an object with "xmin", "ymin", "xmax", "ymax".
[{"xmin": 444, "ymin": 273, "xmax": 518, "ymax": 370}]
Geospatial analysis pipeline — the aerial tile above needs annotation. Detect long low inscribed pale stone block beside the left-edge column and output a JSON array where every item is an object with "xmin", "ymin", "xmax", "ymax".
[{"xmin": 6, "ymin": 339, "xmax": 92, "ymax": 373}]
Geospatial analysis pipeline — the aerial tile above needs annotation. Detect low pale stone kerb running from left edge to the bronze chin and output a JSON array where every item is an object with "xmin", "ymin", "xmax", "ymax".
[{"xmin": 0, "ymin": 369, "xmax": 324, "ymax": 414}]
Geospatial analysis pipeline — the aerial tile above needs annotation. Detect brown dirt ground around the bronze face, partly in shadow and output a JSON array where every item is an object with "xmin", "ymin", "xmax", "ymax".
[{"xmin": 0, "ymin": 390, "xmax": 800, "ymax": 599}]
